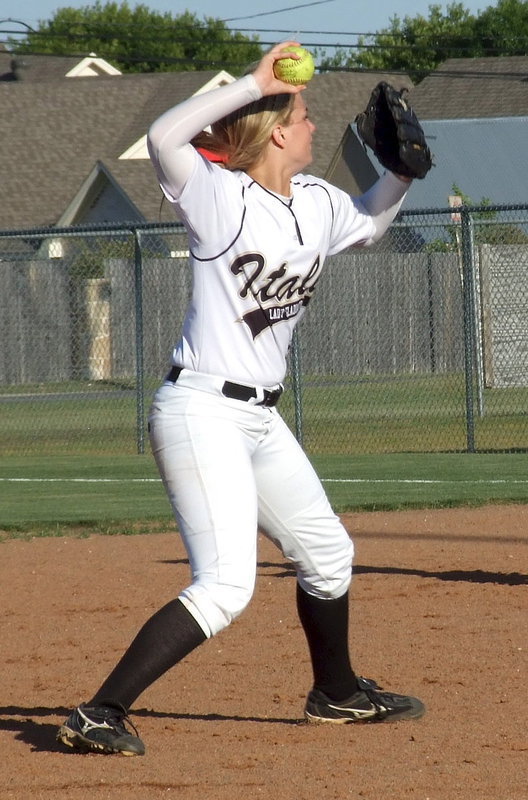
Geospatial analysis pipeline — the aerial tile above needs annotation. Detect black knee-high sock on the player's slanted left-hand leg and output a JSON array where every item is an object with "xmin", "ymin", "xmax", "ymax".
[{"xmin": 88, "ymin": 600, "xmax": 207, "ymax": 709}]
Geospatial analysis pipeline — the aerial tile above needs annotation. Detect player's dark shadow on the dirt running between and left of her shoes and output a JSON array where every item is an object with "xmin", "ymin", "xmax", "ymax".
[{"xmin": 0, "ymin": 706, "xmax": 303, "ymax": 755}]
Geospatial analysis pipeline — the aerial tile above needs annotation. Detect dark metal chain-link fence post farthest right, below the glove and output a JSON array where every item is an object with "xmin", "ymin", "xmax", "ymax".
[{"xmin": 460, "ymin": 205, "xmax": 475, "ymax": 453}]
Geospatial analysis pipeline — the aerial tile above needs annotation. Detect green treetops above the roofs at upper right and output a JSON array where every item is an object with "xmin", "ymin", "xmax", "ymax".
[{"xmin": 322, "ymin": 0, "xmax": 528, "ymax": 80}]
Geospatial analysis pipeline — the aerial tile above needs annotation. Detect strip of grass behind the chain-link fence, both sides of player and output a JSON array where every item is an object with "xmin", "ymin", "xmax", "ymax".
[{"xmin": 0, "ymin": 373, "xmax": 528, "ymax": 456}]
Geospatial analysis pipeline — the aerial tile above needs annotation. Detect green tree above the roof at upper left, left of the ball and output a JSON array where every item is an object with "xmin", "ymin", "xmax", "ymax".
[{"xmin": 12, "ymin": 0, "xmax": 262, "ymax": 75}]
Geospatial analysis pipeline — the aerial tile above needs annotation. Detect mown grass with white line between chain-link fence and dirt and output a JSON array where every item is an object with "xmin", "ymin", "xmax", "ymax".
[{"xmin": 0, "ymin": 454, "xmax": 528, "ymax": 538}]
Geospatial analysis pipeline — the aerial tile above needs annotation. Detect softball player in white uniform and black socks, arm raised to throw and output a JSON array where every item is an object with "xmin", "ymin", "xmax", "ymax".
[{"xmin": 58, "ymin": 42, "xmax": 425, "ymax": 755}]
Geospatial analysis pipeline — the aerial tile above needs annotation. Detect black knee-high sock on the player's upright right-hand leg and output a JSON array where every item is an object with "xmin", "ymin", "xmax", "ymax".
[{"xmin": 297, "ymin": 584, "xmax": 358, "ymax": 700}]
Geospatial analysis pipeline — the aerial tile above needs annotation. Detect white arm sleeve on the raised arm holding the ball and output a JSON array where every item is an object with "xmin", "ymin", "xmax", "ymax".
[{"xmin": 147, "ymin": 75, "xmax": 262, "ymax": 200}]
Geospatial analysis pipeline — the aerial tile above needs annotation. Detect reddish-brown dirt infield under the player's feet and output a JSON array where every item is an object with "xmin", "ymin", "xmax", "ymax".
[{"xmin": 0, "ymin": 506, "xmax": 528, "ymax": 800}]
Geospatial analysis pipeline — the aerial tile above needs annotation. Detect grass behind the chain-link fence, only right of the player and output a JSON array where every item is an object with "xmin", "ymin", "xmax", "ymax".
[{"xmin": 288, "ymin": 374, "xmax": 528, "ymax": 455}]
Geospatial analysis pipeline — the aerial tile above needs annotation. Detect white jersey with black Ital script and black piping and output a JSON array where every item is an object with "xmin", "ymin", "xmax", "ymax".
[{"xmin": 146, "ymin": 76, "xmax": 407, "ymax": 387}]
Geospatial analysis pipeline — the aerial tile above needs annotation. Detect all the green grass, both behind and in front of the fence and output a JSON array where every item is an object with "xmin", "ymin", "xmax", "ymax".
[{"xmin": 0, "ymin": 374, "xmax": 528, "ymax": 535}]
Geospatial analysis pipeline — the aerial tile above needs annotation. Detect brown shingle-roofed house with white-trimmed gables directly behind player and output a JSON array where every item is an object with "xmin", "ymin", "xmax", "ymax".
[{"xmin": 0, "ymin": 52, "xmax": 412, "ymax": 230}]
